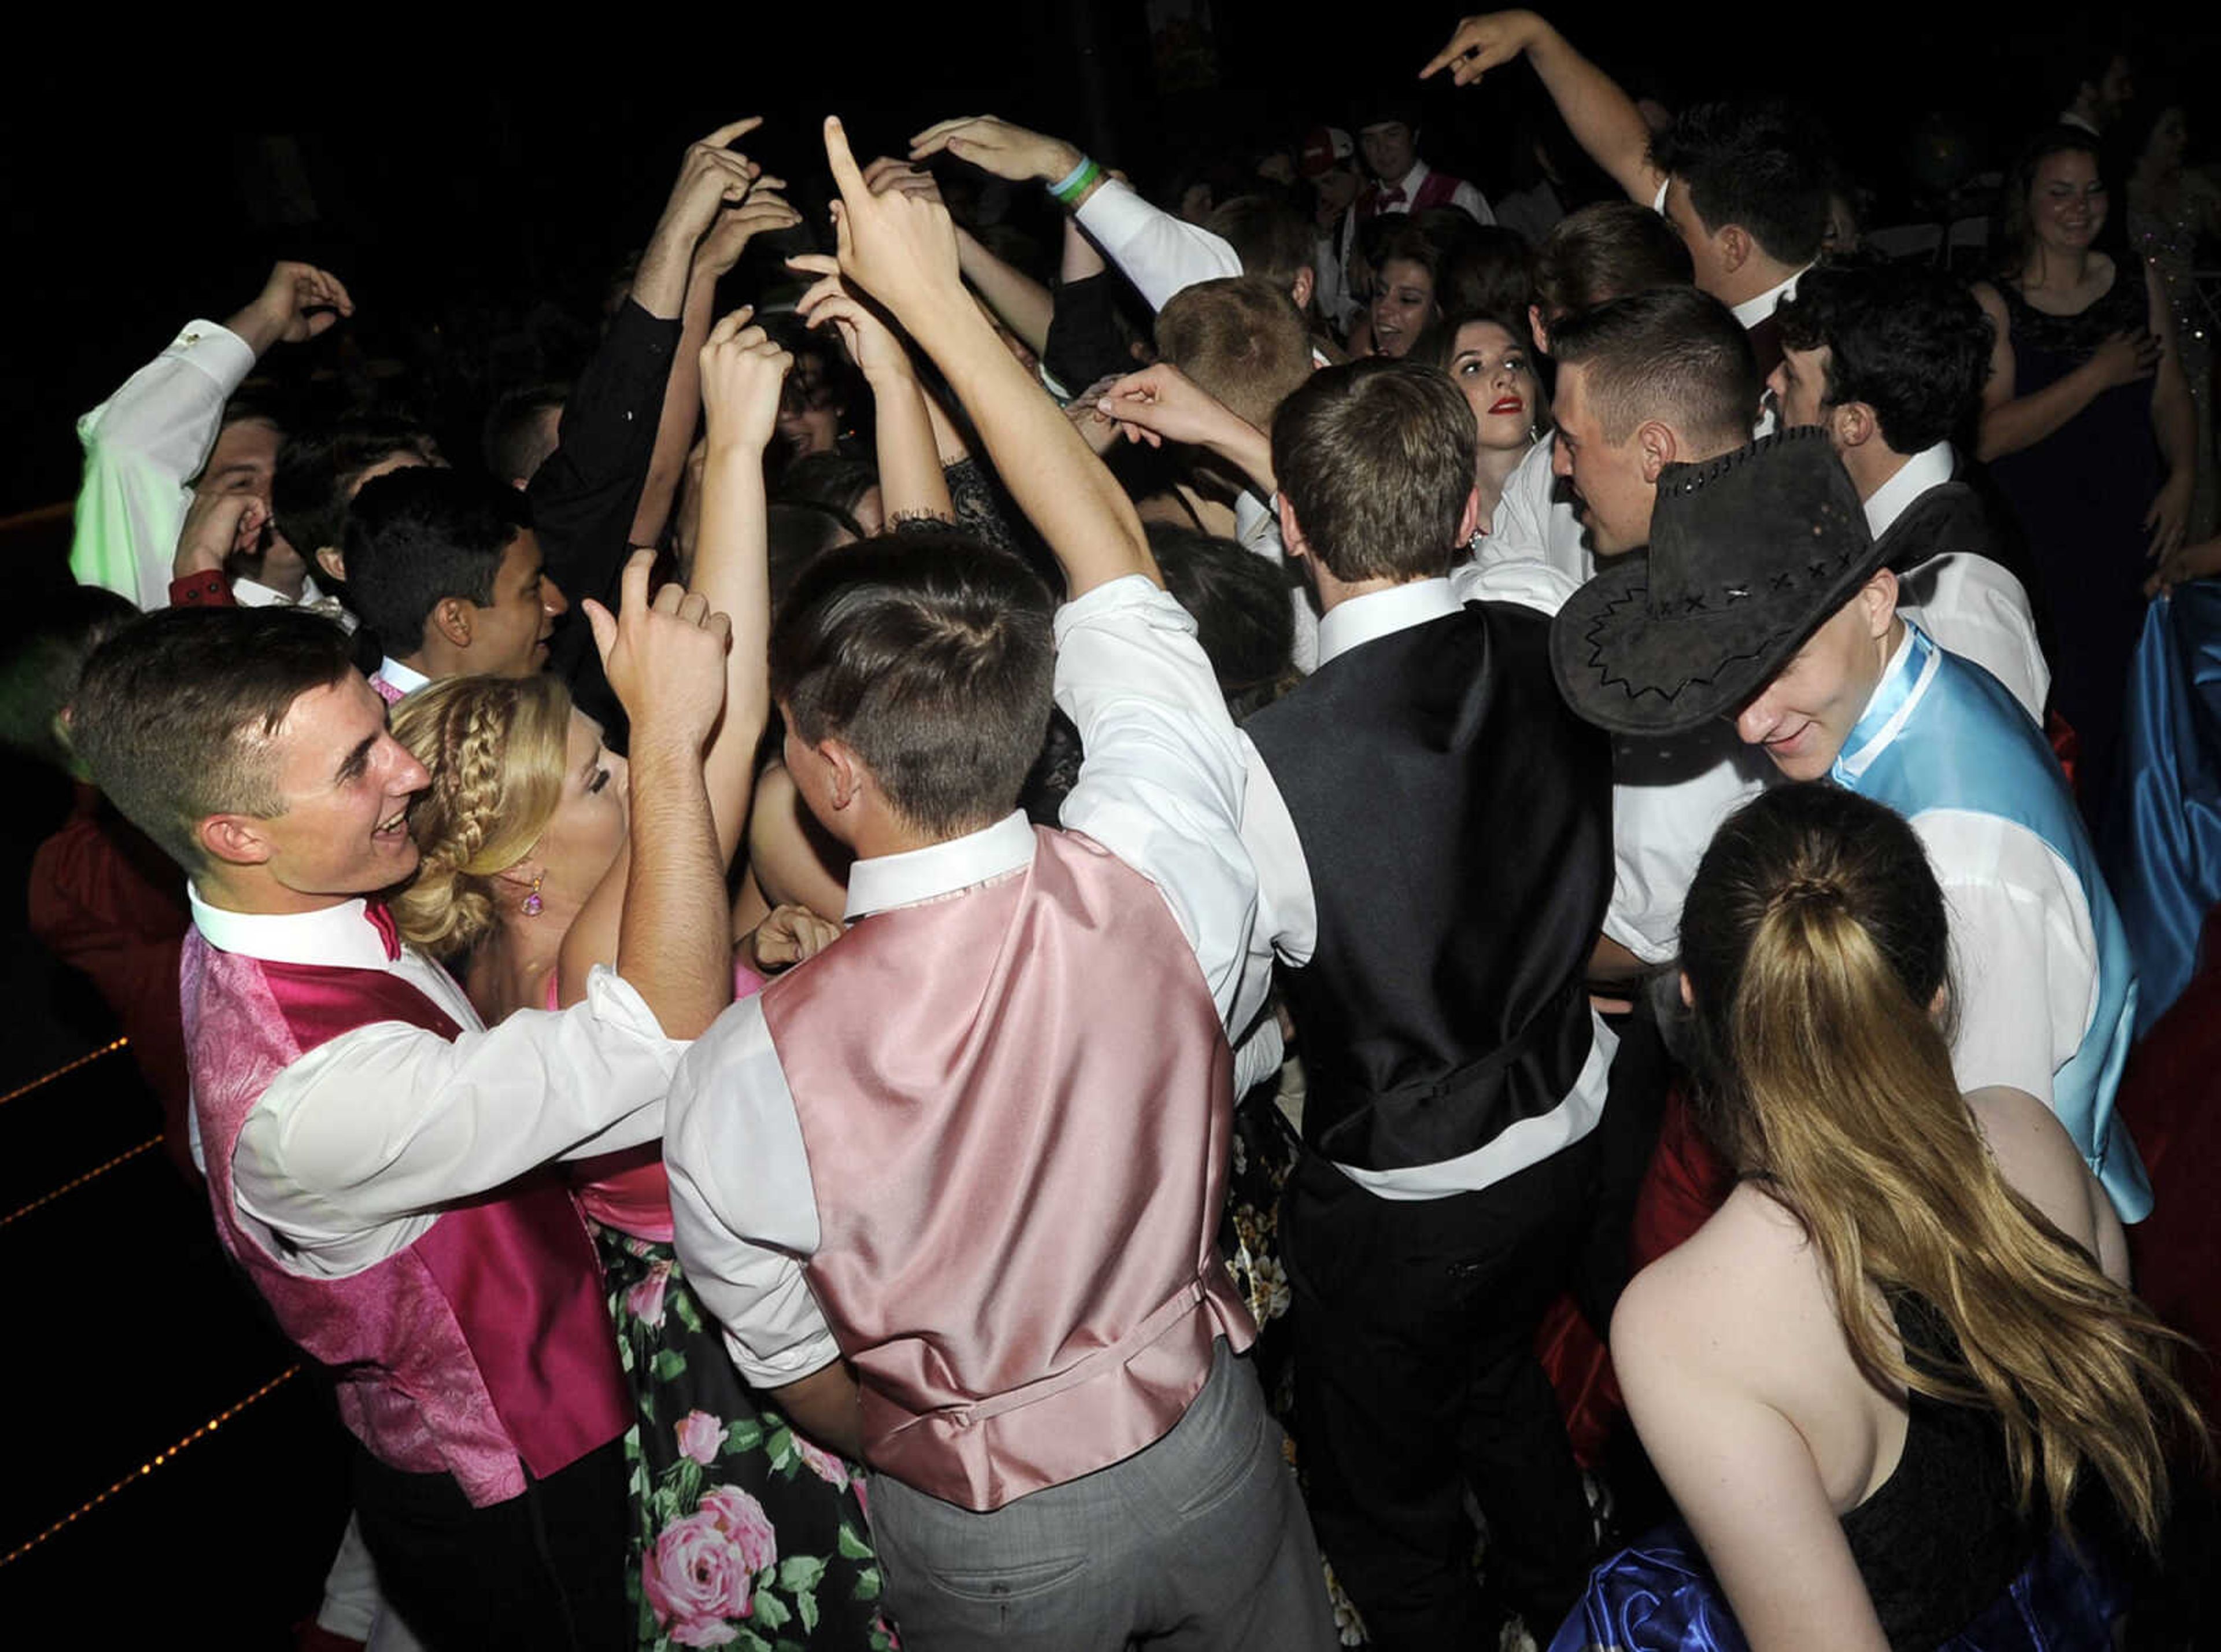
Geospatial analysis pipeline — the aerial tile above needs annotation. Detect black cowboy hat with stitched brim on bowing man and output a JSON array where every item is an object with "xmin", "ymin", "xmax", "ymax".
[{"xmin": 1550, "ymin": 426, "xmax": 1881, "ymax": 735}]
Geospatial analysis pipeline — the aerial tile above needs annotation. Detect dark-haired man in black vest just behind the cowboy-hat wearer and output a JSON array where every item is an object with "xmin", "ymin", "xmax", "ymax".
[{"xmin": 1768, "ymin": 264, "xmax": 2050, "ymax": 724}]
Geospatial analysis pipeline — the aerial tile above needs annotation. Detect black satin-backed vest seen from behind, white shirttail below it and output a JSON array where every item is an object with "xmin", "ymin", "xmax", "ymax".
[{"xmin": 1248, "ymin": 604, "xmax": 1613, "ymax": 1170}]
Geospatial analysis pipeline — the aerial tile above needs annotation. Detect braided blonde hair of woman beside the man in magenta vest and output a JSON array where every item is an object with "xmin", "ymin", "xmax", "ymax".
[{"xmin": 393, "ymin": 675, "xmax": 571, "ymax": 957}]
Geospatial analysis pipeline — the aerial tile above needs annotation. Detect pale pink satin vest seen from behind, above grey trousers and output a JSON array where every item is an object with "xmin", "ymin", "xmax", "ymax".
[{"xmin": 764, "ymin": 831, "xmax": 1257, "ymax": 1510}]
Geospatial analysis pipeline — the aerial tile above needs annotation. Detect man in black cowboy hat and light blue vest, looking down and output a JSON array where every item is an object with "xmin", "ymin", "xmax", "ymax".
[{"xmin": 1550, "ymin": 426, "xmax": 2152, "ymax": 1221}]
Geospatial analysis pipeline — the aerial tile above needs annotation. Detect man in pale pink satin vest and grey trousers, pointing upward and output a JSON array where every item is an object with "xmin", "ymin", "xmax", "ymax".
[{"xmin": 664, "ymin": 122, "xmax": 1335, "ymax": 1652}]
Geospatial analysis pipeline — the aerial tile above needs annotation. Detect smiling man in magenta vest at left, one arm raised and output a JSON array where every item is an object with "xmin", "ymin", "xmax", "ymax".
[{"xmin": 71, "ymin": 558, "xmax": 731, "ymax": 1647}]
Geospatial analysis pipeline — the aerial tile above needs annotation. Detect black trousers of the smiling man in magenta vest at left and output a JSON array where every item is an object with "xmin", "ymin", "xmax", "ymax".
[{"xmin": 355, "ymin": 1437, "xmax": 640, "ymax": 1652}]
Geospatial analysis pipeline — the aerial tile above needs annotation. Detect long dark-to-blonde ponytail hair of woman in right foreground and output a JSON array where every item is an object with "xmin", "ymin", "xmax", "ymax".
[{"xmin": 1681, "ymin": 784, "xmax": 2205, "ymax": 1546}]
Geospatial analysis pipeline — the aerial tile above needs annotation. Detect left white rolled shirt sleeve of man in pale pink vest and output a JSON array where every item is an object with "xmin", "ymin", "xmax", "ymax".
[{"xmin": 664, "ymin": 997, "xmax": 840, "ymax": 1388}]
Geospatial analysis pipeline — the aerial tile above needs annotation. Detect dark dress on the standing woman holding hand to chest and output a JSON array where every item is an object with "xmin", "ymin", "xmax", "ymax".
[{"xmin": 1990, "ymin": 260, "xmax": 2163, "ymax": 819}]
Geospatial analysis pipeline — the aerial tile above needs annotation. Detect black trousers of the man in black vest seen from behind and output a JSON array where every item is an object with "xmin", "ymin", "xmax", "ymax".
[{"xmin": 1282, "ymin": 1137, "xmax": 1597, "ymax": 1652}]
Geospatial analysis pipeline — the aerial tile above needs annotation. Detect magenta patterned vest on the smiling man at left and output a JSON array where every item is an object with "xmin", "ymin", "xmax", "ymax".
[{"xmin": 182, "ymin": 930, "xmax": 633, "ymax": 1507}]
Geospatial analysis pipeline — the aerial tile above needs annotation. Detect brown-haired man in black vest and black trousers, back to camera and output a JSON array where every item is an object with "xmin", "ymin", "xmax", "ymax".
[{"xmin": 1244, "ymin": 360, "xmax": 1613, "ymax": 1647}]
